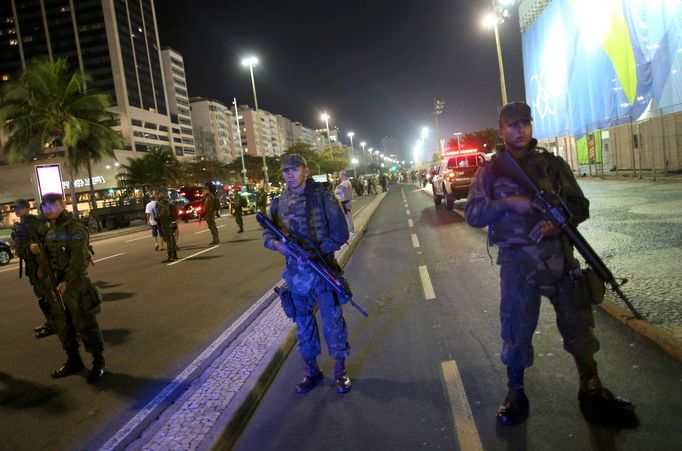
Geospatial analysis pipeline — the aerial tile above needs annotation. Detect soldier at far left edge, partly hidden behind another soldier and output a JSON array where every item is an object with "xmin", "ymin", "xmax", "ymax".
[{"xmin": 12, "ymin": 199, "xmax": 56, "ymax": 338}]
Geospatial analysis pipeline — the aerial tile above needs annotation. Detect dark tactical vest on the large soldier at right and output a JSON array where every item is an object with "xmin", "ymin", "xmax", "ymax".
[{"xmin": 490, "ymin": 147, "xmax": 561, "ymax": 246}]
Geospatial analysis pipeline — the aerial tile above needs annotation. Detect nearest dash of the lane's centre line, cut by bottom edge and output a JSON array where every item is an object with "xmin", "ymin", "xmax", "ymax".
[{"xmin": 440, "ymin": 360, "xmax": 483, "ymax": 451}]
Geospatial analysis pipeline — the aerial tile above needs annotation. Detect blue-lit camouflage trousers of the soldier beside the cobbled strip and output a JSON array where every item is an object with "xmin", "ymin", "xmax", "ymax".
[{"xmin": 291, "ymin": 291, "xmax": 350, "ymax": 360}]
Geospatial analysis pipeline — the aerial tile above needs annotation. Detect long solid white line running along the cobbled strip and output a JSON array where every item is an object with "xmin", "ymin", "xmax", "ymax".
[{"xmin": 99, "ymin": 286, "xmax": 281, "ymax": 451}]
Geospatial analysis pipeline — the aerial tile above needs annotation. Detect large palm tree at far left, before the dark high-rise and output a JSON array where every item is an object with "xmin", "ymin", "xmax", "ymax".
[{"xmin": 0, "ymin": 57, "xmax": 123, "ymax": 213}]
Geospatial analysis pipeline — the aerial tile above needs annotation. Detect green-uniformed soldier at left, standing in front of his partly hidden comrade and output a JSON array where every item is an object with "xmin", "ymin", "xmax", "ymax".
[{"xmin": 30, "ymin": 194, "xmax": 104, "ymax": 384}]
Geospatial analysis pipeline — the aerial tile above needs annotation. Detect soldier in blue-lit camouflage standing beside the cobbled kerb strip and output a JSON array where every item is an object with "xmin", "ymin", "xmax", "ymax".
[{"xmin": 263, "ymin": 154, "xmax": 351, "ymax": 393}]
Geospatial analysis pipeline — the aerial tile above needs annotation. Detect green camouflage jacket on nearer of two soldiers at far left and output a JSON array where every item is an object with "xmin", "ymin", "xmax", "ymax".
[{"xmin": 44, "ymin": 213, "xmax": 90, "ymax": 285}]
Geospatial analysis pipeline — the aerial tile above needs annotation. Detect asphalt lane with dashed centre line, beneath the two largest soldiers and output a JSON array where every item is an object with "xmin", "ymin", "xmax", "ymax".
[{"xmin": 232, "ymin": 185, "xmax": 682, "ymax": 450}]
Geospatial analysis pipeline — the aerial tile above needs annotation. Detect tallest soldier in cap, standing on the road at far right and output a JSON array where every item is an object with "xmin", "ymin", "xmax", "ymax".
[{"xmin": 464, "ymin": 102, "xmax": 636, "ymax": 426}]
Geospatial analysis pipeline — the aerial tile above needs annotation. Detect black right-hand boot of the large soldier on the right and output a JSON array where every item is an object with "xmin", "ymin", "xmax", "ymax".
[{"xmin": 576, "ymin": 358, "xmax": 639, "ymax": 428}]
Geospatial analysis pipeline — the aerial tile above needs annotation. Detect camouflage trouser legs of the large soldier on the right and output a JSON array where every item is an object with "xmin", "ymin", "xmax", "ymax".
[{"xmin": 498, "ymin": 261, "xmax": 599, "ymax": 368}]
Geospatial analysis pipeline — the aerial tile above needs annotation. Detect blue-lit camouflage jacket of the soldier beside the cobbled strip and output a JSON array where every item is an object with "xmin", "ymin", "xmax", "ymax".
[{"xmin": 263, "ymin": 179, "xmax": 348, "ymax": 294}]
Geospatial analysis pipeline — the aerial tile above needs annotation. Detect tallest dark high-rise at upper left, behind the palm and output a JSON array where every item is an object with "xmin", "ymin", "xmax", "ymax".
[{"xmin": 0, "ymin": 0, "xmax": 173, "ymax": 161}]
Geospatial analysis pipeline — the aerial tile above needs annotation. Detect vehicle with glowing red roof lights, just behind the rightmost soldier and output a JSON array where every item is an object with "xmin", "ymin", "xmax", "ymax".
[{"xmin": 431, "ymin": 149, "xmax": 485, "ymax": 210}]
